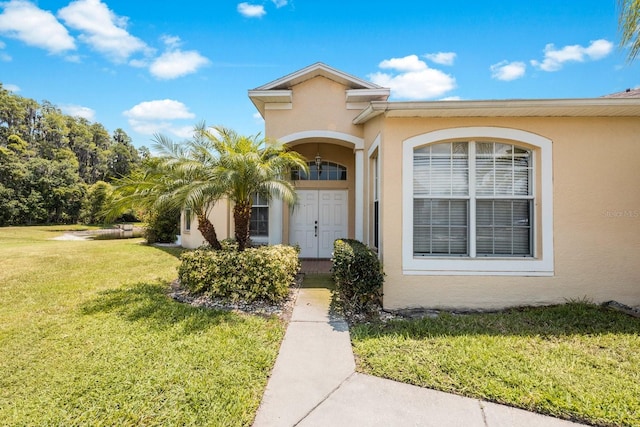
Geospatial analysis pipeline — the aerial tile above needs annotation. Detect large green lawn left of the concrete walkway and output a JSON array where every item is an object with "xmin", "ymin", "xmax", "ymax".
[{"xmin": 0, "ymin": 227, "xmax": 285, "ymax": 426}]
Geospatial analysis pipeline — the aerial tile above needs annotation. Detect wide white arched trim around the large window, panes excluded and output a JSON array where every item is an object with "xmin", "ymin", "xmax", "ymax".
[{"xmin": 402, "ymin": 127, "xmax": 554, "ymax": 276}]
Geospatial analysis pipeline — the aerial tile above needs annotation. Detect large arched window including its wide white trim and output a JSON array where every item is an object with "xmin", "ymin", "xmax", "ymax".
[{"xmin": 403, "ymin": 127, "xmax": 553, "ymax": 275}]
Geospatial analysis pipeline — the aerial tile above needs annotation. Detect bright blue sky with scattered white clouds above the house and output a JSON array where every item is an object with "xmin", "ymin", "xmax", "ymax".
[{"xmin": 0, "ymin": 0, "xmax": 640, "ymax": 146}]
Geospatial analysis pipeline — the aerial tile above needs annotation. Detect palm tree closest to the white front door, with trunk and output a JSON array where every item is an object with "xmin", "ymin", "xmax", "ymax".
[{"xmin": 197, "ymin": 126, "xmax": 308, "ymax": 251}]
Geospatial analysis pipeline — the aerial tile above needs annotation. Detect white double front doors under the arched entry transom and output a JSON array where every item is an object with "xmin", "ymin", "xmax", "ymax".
[{"xmin": 290, "ymin": 190, "xmax": 348, "ymax": 258}]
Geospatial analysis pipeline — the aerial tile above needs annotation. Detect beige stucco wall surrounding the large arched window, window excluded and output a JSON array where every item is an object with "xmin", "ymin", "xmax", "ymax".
[{"xmin": 378, "ymin": 117, "xmax": 640, "ymax": 309}]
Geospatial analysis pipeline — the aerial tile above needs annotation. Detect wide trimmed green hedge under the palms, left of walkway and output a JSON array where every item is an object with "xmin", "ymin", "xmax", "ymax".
[{"xmin": 178, "ymin": 244, "xmax": 300, "ymax": 302}]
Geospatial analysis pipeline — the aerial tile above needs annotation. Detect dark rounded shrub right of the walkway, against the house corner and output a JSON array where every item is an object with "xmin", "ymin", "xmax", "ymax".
[{"xmin": 331, "ymin": 239, "xmax": 384, "ymax": 313}]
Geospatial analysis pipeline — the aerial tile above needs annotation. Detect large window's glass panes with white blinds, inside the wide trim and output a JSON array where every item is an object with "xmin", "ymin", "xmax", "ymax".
[{"xmin": 413, "ymin": 141, "xmax": 533, "ymax": 257}]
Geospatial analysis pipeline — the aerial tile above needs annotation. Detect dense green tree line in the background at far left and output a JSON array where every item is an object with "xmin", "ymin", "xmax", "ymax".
[{"xmin": 0, "ymin": 83, "xmax": 150, "ymax": 226}]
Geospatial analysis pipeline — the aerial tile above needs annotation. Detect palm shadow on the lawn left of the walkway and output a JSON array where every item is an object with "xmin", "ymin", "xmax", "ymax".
[{"xmin": 81, "ymin": 282, "xmax": 244, "ymax": 334}]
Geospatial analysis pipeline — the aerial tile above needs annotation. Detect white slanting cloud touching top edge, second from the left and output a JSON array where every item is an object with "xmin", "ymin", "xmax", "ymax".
[{"xmin": 58, "ymin": 0, "xmax": 151, "ymax": 62}]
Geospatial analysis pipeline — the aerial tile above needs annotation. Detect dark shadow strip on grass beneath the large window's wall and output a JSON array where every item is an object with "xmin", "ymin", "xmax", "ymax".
[{"xmin": 358, "ymin": 302, "xmax": 640, "ymax": 339}]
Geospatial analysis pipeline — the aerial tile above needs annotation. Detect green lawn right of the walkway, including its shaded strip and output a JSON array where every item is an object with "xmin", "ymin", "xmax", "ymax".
[{"xmin": 351, "ymin": 303, "xmax": 640, "ymax": 426}]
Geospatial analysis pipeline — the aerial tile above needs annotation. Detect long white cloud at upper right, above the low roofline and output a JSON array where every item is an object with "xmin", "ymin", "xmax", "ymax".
[{"xmin": 531, "ymin": 39, "xmax": 613, "ymax": 71}]
